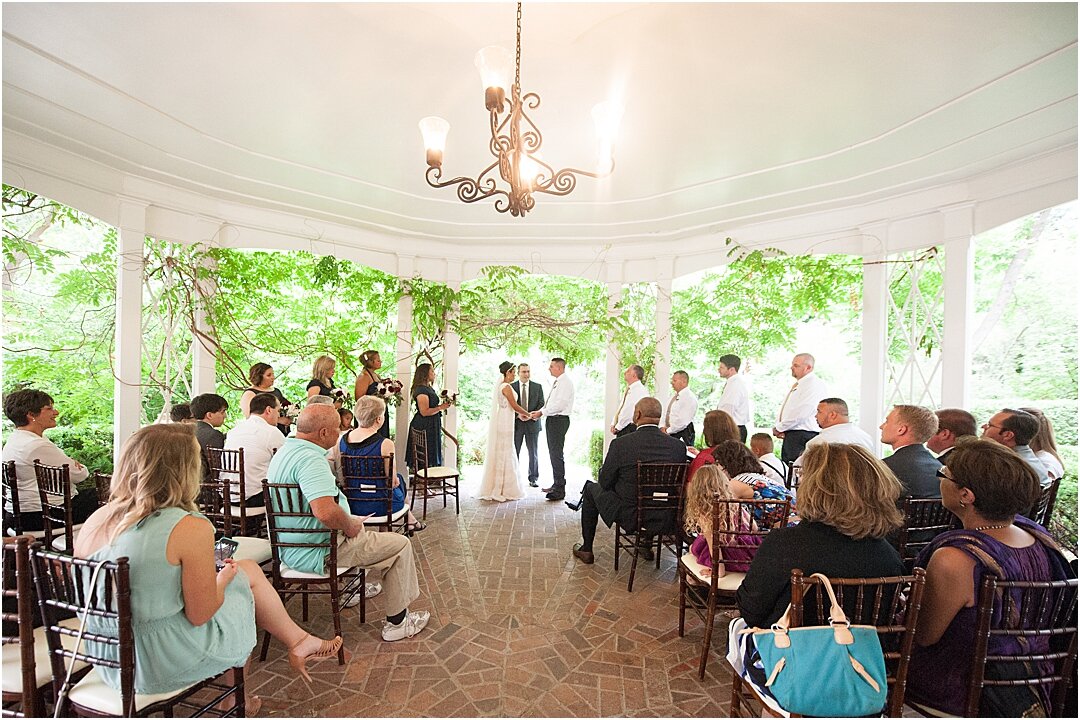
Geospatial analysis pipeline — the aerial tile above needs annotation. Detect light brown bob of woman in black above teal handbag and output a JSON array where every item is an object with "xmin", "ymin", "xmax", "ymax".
[{"xmin": 799, "ymin": 443, "xmax": 904, "ymax": 540}]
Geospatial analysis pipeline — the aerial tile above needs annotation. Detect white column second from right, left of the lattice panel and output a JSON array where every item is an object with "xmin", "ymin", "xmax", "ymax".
[{"xmin": 859, "ymin": 226, "xmax": 889, "ymax": 443}]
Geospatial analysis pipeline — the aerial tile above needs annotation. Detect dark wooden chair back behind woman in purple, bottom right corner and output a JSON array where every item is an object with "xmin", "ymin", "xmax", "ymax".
[{"xmin": 964, "ymin": 573, "xmax": 1078, "ymax": 718}]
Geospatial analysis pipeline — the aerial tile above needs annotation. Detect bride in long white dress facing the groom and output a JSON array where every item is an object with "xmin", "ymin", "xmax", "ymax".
[{"xmin": 477, "ymin": 362, "xmax": 528, "ymax": 502}]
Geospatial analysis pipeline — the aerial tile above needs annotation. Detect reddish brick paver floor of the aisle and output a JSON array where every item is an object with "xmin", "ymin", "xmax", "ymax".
[{"xmin": 247, "ymin": 468, "xmax": 730, "ymax": 717}]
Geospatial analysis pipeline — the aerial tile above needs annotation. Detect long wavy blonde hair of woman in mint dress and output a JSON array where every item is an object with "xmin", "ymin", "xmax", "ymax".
[{"xmin": 105, "ymin": 423, "xmax": 202, "ymax": 542}]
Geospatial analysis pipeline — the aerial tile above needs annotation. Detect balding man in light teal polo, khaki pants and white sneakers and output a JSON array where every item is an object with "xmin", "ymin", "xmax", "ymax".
[{"xmin": 267, "ymin": 405, "xmax": 431, "ymax": 642}]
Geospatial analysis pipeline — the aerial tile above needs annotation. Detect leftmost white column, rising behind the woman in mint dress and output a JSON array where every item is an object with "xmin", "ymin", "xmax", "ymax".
[{"xmin": 112, "ymin": 200, "xmax": 147, "ymax": 464}]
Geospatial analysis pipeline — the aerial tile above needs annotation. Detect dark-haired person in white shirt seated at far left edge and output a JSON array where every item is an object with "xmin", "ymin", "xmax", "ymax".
[{"xmin": 3, "ymin": 389, "xmax": 97, "ymax": 531}]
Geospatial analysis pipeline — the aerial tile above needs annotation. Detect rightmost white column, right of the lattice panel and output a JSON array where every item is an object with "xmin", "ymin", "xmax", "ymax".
[{"xmin": 941, "ymin": 206, "xmax": 975, "ymax": 408}]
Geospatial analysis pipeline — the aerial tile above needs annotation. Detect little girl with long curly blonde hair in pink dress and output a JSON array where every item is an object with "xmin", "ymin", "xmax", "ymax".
[{"xmin": 685, "ymin": 464, "xmax": 761, "ymax": 576}]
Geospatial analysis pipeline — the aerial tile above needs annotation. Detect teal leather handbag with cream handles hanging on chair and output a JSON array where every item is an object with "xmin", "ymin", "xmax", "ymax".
[{"xmin": 752, "ymin": 573, "xmax": 889, "ymax": 718}]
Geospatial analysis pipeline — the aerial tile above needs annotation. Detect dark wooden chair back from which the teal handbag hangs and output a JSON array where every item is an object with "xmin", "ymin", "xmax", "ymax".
[{"xmin": 789, "ymin": 568, "xmax": 926, "ymax": 718}]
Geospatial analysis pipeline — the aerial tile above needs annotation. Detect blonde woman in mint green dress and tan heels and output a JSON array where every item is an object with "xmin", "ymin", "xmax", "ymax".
[{"xmin": 75, "ymin": 424, "xmax": 341, "ymax": 715}]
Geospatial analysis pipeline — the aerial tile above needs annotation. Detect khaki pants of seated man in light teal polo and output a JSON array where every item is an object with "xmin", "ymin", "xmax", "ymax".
[{"xmin": 338, "ymin": 530, "xmax": 420, "ymax": 615}]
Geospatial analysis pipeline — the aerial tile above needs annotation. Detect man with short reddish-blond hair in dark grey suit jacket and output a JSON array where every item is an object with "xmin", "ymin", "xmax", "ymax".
[{"xmin": 881, "ymin": 405, "xmax": 942, "ymax": 504}]
